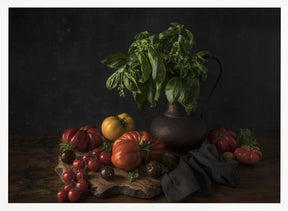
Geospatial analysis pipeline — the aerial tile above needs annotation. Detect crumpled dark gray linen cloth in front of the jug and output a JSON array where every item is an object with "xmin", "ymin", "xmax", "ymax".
[{"xmin": 161, "ymin": 140, "xmax": 239, "ymax": 202}]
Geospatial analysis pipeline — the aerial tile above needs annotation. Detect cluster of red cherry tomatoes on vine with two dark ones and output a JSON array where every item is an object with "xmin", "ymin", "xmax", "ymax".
[{"xmin": 57, "ymin": 148, "xmax": 114, "ymax": 202}]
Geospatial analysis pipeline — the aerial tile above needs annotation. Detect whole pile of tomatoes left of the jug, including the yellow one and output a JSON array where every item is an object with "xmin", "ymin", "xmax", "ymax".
[{"xmin": 57, "ymin": 113, "xmax": 165, "ymax": 202}]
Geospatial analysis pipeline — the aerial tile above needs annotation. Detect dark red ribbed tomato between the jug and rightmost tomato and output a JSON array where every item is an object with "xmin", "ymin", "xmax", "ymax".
[{"xmin": 208, "ymin": 127, "xmax": 237, "ymax": 153}]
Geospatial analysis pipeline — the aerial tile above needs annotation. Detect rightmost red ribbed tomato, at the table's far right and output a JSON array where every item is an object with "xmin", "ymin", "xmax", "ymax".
[{"xmin": 234, "ymin": 146, "xmax": 262, "ymax": 166}]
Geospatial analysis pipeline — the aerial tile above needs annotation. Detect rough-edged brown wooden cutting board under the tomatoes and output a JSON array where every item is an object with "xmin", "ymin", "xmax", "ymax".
[{"xmin": 55, "ymin": 157, "xmax": 162, "ymax": 199}]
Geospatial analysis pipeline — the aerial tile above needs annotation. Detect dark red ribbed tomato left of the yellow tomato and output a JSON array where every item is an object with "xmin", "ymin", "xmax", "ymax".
[{"xmin": 62, "ymin": 125, "xmax": 102, "ymax": 152}]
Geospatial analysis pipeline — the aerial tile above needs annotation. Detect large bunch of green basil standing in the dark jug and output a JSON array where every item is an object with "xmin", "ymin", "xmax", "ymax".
[{"xmin": 102, "ymin": 23, "xmax": 211, "ymax": 115}]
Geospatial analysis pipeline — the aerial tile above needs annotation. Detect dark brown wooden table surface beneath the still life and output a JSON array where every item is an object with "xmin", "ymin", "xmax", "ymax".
[{"xmin": 8, "ymin": 134, "xmax": 280, "ymax": 203}]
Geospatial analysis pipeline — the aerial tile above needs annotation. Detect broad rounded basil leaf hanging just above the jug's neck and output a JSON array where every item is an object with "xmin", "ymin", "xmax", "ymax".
[{"xmin": 165, "ymin": 77, "xmax": 182, "ymax": 104}]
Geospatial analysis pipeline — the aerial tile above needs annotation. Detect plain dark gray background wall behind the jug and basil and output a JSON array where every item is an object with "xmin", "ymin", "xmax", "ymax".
[{"xmin": 9, "ymin": 8, "xmax": 280, "ymax": 134}]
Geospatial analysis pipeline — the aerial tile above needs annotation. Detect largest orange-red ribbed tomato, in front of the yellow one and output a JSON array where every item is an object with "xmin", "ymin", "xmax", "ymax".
[{"xmin": 111, "ymin": 131, "xmax": 165, "ymax": 171}]
